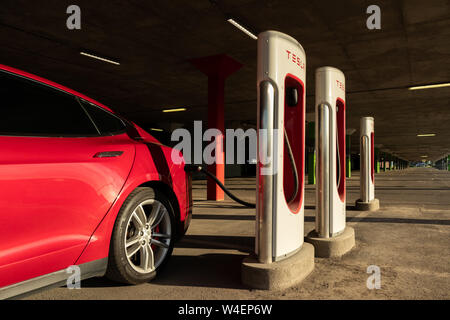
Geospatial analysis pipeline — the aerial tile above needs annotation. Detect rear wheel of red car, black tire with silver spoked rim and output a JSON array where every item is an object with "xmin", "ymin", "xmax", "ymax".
[{"xmin": 106, "ymin": 187, "xmax": 176, "ymax": 284}]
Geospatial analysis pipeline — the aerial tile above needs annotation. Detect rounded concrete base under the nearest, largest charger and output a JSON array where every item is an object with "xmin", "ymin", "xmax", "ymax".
[{"xmin": 241, "ymin": 242, "xmax": 314, "ymax": 290}]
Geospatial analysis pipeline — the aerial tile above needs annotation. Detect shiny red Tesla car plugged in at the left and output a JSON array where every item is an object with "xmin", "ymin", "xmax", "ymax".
[{"xmin": 0, "ymin": 65, "xmax": 192, "ymax": 298}]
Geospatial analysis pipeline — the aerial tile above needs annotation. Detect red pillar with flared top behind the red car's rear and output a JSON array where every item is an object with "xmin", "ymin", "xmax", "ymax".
[{"xmin": 190, "ymin": 54, "xmax": 242, "ymax": 201}]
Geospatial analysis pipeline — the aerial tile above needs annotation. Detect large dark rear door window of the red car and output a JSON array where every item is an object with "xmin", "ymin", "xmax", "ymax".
[{"xmin": 0, "ymin": 72, "xmax": 99, "ymax": 137}]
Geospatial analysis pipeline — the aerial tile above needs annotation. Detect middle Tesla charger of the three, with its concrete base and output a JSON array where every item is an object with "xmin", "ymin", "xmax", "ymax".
[{"xmin": 307, "ymin": 67, "xmax": 355, "ymax": 257}]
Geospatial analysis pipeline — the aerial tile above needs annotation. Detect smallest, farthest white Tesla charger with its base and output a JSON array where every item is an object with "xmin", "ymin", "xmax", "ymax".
[{"xmin": 356, "ymin": 117, "xmax": 380, "ymax": 211}]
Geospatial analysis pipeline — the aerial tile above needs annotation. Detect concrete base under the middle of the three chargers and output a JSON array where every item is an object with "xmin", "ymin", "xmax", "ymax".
[{"xmin": 305, "ymin": 227, "xmax": 355, "ymax": 258}]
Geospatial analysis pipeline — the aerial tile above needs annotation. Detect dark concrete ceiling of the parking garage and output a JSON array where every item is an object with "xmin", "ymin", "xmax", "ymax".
[{"xmin": 0, "ymin": 0, "xmax": 450, "ymax": 160}]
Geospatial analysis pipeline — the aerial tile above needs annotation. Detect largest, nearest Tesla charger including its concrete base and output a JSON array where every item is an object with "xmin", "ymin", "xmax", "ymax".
[{"xmin": 242, "ymin": 31, "xmax": 314, "ymax": 289}]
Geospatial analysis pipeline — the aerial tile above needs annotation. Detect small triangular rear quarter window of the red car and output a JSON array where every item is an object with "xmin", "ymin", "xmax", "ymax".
[{"xmin": 80, "ymin": 99, "xmax": 126, "ymax": 135}]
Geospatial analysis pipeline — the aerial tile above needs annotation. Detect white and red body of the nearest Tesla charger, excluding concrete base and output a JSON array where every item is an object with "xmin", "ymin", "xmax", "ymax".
[{"xmin": 255, "ymin": 32, "xmax": 306, "ymax": 263}]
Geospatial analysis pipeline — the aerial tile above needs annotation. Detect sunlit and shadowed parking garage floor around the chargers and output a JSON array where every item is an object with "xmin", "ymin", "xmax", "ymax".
[{"xmin": 27, "ymin": 168, "xmax": 450, "ymax": 300}]
